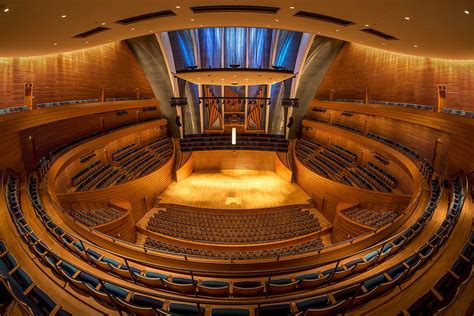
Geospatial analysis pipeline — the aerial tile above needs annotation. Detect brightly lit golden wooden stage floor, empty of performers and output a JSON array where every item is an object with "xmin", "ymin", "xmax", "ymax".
[{"xmin": 159, "ymin": 170, "xmax": 310, "ymax": 209}]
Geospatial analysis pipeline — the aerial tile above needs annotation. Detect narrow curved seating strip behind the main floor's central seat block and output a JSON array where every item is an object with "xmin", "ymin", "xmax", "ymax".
[{"xmin": 144, "ymin": 237, "xmax": 324, "ymax": 260}]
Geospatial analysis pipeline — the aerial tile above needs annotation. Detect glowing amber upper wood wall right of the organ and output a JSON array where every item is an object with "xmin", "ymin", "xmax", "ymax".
[{"xmin": 316, "ymin": 43, "xmax": 474, "ymax": 111}]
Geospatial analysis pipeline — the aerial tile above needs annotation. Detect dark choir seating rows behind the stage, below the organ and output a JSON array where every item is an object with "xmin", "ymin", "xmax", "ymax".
[{"xmin": 179, "ymin": 133, "xmax": 288, "ymax": 152}]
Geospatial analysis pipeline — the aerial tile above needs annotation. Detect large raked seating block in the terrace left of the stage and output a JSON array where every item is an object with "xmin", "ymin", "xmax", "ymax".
[{"xmin": 71, "ymin": 137, "xmax": 173, "ymax": 192}]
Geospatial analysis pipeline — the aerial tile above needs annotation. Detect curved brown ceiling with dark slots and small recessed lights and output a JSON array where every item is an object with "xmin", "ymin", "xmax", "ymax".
[{"xmin": 0, "ymin": 0, "xmax": 474, "ymax": 59}]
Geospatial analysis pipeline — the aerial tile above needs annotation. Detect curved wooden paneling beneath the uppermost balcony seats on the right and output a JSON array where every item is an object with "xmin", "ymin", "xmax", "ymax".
[{"xmin": 309, "ymin": 100, "xmax": 474, "ymax": 176}]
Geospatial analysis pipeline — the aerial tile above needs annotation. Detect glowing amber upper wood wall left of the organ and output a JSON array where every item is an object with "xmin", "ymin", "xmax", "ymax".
[{"xmin": 0, "ymin": 42, "xmax": 153, "ymax": 107}]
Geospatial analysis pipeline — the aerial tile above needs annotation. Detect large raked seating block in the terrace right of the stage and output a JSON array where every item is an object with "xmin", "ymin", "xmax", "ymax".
[{"xmin": 295, "ymin": 138, "xmax": 397, "ymax": 192}]
